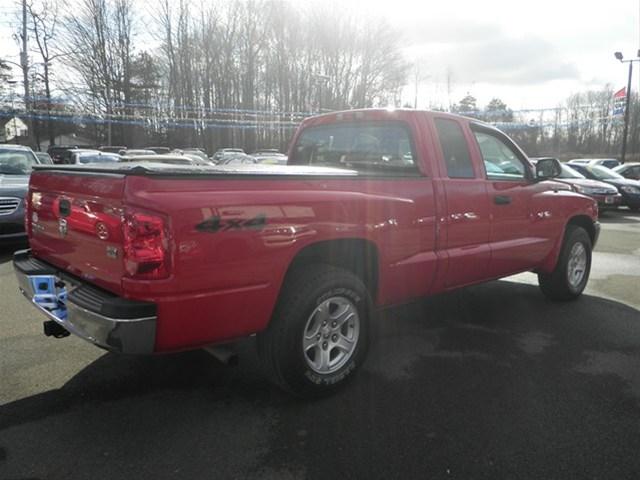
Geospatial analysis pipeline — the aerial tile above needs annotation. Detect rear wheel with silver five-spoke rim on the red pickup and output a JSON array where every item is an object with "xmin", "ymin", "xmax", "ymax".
[{"xmin": 257, "ymin": 264, "xmax": 372, "ymax": 398}]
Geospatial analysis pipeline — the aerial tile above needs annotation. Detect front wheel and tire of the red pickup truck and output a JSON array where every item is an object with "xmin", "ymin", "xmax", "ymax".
[{"xmin": 538, "ymin": 225, "xmax": 592, "ymax": 301}]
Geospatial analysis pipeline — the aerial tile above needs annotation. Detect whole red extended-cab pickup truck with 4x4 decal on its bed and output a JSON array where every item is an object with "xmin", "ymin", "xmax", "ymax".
[{"xmin": 14, "ymin": 110, "xmax": 599, "ymax": 396}]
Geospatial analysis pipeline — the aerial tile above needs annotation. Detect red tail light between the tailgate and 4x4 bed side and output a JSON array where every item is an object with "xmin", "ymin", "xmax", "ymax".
[{"xmin": 123, "ymin": 212, "xmax": 169, "ymax": 280}]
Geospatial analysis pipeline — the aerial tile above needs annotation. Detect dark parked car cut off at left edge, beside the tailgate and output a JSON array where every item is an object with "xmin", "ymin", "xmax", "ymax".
[{"xmin": 0, "ymin": 145, "xmax": 39, "ymax": 241}]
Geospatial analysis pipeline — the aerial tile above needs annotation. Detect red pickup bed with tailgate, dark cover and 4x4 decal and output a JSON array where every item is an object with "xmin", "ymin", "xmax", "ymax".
[{"xmin": 29, "ymin": 162, "xmax": 436, "ymax": 351}]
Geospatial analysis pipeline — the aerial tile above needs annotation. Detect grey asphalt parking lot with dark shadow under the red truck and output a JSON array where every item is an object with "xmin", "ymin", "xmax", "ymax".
[{"xmin": 0, "ymin": 210, "xmax": 640, "ymax": 479}]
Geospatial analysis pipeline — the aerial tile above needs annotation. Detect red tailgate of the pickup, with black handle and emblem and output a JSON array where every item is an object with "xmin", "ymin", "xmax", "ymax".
[{"xmin": 27, "ymin": 171, "xmax": 125, "ymax": 294}]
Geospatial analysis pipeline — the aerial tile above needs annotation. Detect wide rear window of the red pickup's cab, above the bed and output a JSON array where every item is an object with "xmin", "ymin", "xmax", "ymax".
[{"xmin": 289, "ymin": 122, "xmax": 419, "ymax": 176}]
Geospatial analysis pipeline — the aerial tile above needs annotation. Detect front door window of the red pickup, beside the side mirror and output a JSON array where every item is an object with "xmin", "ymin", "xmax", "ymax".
[{"xmin": 473, "ymin": 131, "xmax": 526, "ymax": 181}]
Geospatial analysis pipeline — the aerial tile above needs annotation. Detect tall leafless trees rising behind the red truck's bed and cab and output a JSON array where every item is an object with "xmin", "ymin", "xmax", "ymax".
[{"xmin": 8, "ymin": 0, "xmax": 408, "ymax": 150}]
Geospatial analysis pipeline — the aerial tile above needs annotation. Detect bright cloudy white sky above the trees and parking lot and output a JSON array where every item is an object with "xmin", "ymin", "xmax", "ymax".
[{"xmin": 0, "ymin": 0, "xmax": 640, "ymax": 109}]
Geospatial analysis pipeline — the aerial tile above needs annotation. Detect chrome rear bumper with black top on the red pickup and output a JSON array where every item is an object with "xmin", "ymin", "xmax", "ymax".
[{"xmin": 13, "ymin": 250, "xmax": 157, "ymax": 354}]
